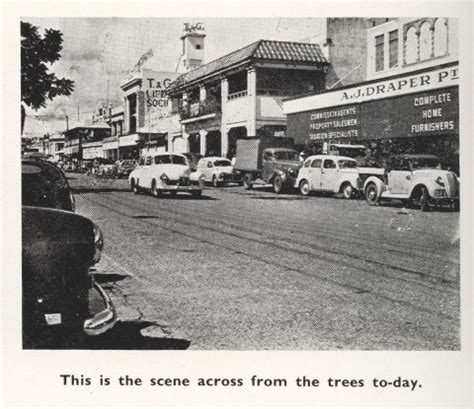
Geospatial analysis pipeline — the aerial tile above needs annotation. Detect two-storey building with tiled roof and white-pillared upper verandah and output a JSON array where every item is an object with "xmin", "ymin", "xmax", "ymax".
[{"xmin": 168, "ymin": 36, "xmax": 329, "ymax": 158}]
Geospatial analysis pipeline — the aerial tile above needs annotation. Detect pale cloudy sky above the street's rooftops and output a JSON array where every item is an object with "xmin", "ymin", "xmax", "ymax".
[{"xmin": 22, "ymin": 17, "xmax": 326, "ymax": 137}]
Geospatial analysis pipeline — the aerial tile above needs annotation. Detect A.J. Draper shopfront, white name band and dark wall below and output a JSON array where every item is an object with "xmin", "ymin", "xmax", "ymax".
[{"xmin": 285, "ymin": 64, "xmax": 459, "ymax": 173}]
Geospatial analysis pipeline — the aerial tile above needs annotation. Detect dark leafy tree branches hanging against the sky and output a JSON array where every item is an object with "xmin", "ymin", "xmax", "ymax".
[{"xmin": 21, "ymin": 21, "xmax": 74, "ymax": 134}]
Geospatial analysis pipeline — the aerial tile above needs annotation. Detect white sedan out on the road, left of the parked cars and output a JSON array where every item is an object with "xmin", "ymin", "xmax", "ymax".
[{"xmin": 128, "ymin": 153, "xmax": 204, "ymax": 197}]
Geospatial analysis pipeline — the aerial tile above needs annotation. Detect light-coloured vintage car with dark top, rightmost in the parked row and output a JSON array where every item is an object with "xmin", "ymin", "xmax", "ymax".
[{"xmin": 364, "ymin": 154, "xmax": 459, "ymax": 211}]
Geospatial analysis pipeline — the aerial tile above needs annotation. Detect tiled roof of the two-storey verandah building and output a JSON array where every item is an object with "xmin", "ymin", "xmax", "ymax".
[{"xmin": 174, "ymin": 40, "xmax": 329, "ymax": 88}]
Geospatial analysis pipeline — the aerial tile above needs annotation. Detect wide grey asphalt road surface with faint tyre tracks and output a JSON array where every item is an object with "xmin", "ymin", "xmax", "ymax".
[{"xmin": 68, "ymin": 174, "xmax": 460, "ymax": 350}]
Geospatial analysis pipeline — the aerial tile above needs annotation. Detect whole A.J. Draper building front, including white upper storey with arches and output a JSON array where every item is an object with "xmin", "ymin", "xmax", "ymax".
[{"xmin": 284, "ymin": 18, "xmax": 460, "ymax": 173}]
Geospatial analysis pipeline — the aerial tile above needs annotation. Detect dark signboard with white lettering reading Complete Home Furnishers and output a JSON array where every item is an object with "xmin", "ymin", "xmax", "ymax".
[{"xmin": 287, "ymin": 87, "xmax": 459, "ymax": 144}]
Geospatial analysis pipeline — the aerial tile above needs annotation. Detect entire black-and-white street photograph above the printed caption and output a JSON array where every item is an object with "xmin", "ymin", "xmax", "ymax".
[{"xmin": 21, "ymin": 17, "xmax": 461, "ymax": 351}]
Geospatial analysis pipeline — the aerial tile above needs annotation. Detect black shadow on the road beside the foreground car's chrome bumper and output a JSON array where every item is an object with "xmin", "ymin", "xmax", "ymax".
[{"xmin": 81, "ymin": 320, "xmax": 191, "ymax": 350}]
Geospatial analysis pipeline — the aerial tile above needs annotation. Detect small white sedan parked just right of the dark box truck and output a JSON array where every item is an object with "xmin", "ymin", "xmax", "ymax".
[{"xmin": 295, "ymin": 155, "xmax": 360, "ymax": 199}]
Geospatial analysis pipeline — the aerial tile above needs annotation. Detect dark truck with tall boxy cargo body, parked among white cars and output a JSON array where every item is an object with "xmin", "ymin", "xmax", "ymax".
[{"xmin": 234, "ymin": 137, "xmax": 302, "ymax": 193}]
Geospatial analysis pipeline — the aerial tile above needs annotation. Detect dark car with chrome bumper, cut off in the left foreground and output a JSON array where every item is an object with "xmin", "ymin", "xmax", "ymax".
[{"xmin": 22, "ymin": 159, "xmax": 116, "ymax": 349}]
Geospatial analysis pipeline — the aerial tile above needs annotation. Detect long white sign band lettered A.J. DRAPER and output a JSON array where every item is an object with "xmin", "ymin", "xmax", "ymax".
[{"xmin": 283, "ymin": 65, "xmax": 459, "ymax": 115}]
